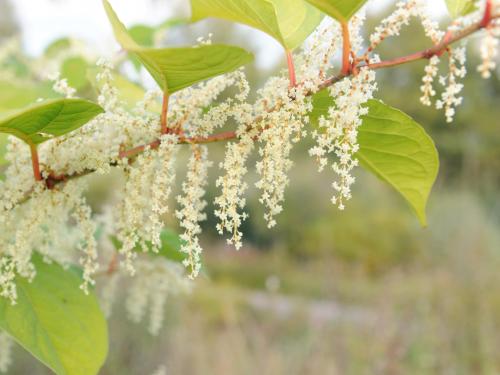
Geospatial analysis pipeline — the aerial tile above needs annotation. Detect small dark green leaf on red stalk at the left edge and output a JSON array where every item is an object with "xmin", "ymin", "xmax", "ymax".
[{"xmin": 0, "ymin": 99, "xmax": 103, "ymax": 145}]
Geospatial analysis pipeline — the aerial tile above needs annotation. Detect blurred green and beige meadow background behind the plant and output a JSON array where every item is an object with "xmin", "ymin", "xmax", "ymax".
[{"xmin": 0, "ymin": 1, "xmax": 500, "ymax": 375}]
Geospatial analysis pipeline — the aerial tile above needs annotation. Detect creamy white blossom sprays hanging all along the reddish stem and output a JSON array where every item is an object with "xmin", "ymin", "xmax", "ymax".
[{"xmin": 0, "ymin": 5, "xmax": 500, "ymax": 356}]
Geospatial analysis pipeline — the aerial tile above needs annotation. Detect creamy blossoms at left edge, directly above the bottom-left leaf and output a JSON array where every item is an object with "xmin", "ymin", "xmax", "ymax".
[{"xmin": 0, "ymin": 170, "xmax": 98, "ymax": 302}]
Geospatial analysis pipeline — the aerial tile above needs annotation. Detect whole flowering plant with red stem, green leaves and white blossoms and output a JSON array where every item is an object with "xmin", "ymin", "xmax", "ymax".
[{"xmin": 0, "ymin": 0, "xmax": 500, "ymax": 375}]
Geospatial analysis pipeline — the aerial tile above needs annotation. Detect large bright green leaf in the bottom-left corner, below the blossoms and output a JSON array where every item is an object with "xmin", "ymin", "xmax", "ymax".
[{"xmin": 0, "ymin": 256, "xmax": 108, "ymax": 375}]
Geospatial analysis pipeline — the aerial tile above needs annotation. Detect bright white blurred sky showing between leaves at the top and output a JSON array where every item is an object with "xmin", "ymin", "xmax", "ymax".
[{"xmin": 12, "ymin": 0, "xmax": 445, "ymax": 67}]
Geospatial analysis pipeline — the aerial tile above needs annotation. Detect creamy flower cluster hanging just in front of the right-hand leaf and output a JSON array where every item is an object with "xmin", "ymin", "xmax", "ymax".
[{"xmin": 309, "ymin": 68, "xmax": 377, "ymax": 210}]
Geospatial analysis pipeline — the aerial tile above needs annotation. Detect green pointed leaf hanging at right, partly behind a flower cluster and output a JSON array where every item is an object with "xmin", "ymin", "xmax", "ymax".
[{"xmin": 310, "ymin": 90, "xmax": 439, "ymax": 226}]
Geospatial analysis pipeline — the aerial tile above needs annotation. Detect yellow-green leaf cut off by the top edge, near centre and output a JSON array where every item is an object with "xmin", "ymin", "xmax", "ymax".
[{"xmin": 191, "ymin": 0, "xmax": 323, "ymax": 50}]
